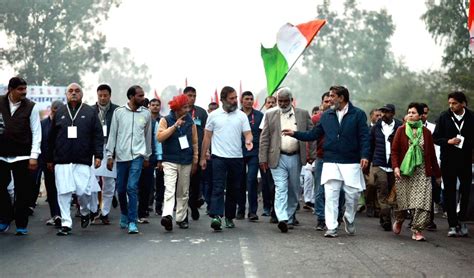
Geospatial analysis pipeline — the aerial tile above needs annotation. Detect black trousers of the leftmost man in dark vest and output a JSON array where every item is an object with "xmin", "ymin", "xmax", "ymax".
[{"xmin": 0, "ymin": 159, "xmax": 34, "ymax": 228}]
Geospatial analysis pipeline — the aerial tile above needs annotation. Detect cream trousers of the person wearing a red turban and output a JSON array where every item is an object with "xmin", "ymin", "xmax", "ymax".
[{"xmin": 162, "ymin": 162, "xmax": 191, "ymax": 222}]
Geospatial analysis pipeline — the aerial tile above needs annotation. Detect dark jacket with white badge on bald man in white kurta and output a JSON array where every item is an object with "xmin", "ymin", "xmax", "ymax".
[{"xmin": 46, "ymin": 104, "xmax": 104, "ymax": 165}]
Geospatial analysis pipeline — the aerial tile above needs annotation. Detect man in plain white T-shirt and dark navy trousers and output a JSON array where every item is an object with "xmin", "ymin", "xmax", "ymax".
[{"xmin": 199, "ymin": 87, "xmax": 253, "ymax": 231}]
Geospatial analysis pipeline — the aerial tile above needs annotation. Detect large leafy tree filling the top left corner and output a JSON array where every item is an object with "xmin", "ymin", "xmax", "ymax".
[{"xmin": 0, "ymin": 0, "xmax": 120, "ymax": 85}]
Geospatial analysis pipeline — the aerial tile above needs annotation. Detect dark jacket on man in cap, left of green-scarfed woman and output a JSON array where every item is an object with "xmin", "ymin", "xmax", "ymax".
[{"xmin": 370, "ymin": 119, "xmax": 402, "ymax": 168}]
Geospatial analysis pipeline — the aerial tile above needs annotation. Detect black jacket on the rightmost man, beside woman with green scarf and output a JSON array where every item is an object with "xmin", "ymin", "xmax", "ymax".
[{"xmin": 433, "ymin": 108, "xmax": 474, "ymax": 164}]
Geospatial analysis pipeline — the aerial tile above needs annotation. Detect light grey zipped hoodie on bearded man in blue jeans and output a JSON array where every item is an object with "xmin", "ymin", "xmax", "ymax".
[{"xmin": 106, "ymin": 104, "xmax": 151, "ymax": 162}]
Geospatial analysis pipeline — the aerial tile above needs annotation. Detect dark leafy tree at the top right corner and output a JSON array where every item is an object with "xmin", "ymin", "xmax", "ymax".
[{"xmin": 421, "ymin": 0, "xmax": 474, "ymax": 91}]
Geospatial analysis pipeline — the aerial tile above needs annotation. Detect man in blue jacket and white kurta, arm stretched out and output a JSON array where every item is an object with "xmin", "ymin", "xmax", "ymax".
[{"xmin": 282, "ymin": 86, "xmax": 370, "ymax": 237}]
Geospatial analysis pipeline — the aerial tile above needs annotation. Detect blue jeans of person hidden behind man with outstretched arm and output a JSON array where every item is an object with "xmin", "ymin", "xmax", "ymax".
[{"xmin": 313, "ymin": 158, "xmax": 346, "ymax": 222}]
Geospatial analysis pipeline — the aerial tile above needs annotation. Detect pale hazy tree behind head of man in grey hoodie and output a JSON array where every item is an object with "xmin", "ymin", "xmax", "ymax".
[{"xmin": 99, "ymin": 48, "xmax": 151, "ymax": 105}]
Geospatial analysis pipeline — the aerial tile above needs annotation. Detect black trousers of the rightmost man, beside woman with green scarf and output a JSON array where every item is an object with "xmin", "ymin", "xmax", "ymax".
[{"xmin": 441, "ymin": 162, "xmax": 472, "ymax": 228}]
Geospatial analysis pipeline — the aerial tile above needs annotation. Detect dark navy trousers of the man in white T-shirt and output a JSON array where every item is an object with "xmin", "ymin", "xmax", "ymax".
[{"xmin": 209, "ymin": 155, "xmax": 244, "ymax": 219}]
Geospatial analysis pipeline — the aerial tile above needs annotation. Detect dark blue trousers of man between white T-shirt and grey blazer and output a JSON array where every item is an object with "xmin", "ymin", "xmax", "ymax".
[{"xmin": 238, "ymin": 156, "xmax": 259, "ymax": 214}]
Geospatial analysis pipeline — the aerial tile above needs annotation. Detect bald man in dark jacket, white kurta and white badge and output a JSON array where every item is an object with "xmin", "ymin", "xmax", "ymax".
[{"xmin": 46, "ymin": 83, "xmax": 104, "ymax": 236}]
